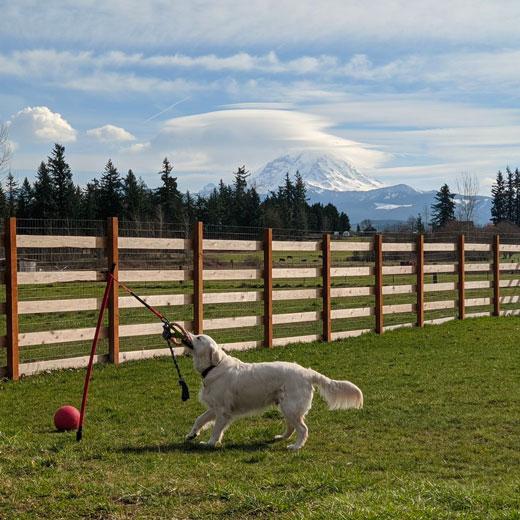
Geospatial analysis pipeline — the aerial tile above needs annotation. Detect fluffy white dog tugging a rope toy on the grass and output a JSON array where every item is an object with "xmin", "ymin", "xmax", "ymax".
[{"xmin": 184, "ymin": 334, "xmax": 363, "ymax": 450}]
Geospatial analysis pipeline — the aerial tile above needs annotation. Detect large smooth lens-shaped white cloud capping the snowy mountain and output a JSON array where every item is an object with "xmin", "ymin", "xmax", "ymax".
[{"xmin": 151, "ymin": 109, "xmax": 386, "ymax": 174}]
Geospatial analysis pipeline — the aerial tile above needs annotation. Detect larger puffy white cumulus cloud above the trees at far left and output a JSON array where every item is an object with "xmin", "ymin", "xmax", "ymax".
[{"xmin": 8, "ymin": 106, "xmax": 76, "ymax": 143}]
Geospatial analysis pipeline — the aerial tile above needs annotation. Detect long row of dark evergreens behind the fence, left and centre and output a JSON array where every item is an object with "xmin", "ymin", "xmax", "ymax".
[{"xmin": 0, "ymin": 144, "xmax": 350, "ymax": 232}]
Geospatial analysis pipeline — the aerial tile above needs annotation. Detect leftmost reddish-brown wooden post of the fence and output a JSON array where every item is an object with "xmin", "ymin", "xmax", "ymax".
[{"xmin": 5, "ymin": 217, "xmax": 20, "ymax": 381}]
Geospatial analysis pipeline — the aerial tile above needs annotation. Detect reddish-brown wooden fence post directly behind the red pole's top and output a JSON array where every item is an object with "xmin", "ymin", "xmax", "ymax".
[{"xmin": 107, "ymin": 217, "xmax": 119, "ymax": 365}]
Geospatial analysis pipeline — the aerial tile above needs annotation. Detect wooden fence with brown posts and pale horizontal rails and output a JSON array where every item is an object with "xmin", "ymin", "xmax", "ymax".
[{"xmin": 0, "ymin": 218, "xmax": 520, "ymax": 379}]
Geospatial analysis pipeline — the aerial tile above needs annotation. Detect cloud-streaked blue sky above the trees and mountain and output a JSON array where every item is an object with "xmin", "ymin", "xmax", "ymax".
[{"xmin": 0, "ymin": 0, "xmax": 520, "ymax": 193}]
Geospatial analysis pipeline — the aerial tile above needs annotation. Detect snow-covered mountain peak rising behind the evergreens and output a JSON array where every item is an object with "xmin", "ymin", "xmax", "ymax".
[{"xmin": 251, "ymin": 151, "xmax": 383, "ymax": 194}]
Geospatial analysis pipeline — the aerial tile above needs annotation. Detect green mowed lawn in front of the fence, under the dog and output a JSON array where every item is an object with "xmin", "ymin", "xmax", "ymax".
[{"xmin": 0, "ymin": 318, "xmax": 520, "ymax": 519}]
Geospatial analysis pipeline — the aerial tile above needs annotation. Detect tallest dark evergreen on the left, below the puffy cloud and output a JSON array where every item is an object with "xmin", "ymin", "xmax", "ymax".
[{"xmin": 47, "ymin": 143, "xmax": 78, "ymax": 218}]
